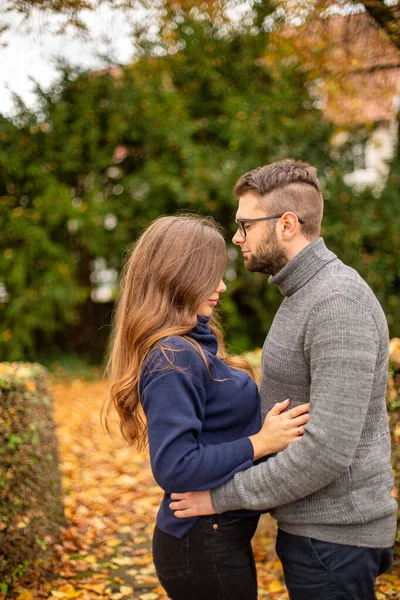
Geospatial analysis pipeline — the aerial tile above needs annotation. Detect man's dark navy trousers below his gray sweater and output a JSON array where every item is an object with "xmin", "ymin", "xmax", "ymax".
[{"xmin": 276, "ymin": 529, "xmax": 393, "ymax": 600}]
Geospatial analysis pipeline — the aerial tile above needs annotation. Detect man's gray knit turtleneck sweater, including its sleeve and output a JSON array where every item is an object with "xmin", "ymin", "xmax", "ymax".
[{"xmin": 212, "ymin": 238, "xmax": 397, "ymax": 547}]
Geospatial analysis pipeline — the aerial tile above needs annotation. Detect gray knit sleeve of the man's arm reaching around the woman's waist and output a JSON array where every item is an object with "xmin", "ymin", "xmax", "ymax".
[{"xmin": 211, "ymin": 292, "xmax": 379, "ymax": 513}]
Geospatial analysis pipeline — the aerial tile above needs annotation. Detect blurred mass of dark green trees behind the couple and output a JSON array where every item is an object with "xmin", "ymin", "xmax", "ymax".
[{"xmin": 0, "ymin": 3, "xmax": 400, "ymax": 360}]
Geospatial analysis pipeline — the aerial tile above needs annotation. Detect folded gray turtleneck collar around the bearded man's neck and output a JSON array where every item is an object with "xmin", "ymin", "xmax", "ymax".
[{"xmin": 268, "ymin": 238, "xmax": 337, "ymax": 296}]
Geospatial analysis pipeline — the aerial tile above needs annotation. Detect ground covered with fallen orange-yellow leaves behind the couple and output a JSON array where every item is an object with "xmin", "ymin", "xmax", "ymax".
[{"xmin": 8, "ymin": 379, "xmax": 400, "ymax": 600}]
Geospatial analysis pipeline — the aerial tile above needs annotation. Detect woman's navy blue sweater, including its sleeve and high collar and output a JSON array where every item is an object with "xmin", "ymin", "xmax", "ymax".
[{"xmin": 140, "ymin": 317, "xmax": 261, "ymax": 538}]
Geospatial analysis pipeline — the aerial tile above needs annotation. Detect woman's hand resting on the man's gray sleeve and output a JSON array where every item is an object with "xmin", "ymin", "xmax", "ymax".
[{"xmin": 249, "ymin": 399, "xmax": 310, "ymax": 460}]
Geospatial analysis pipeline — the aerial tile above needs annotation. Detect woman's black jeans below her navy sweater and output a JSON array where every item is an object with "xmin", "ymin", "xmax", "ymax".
[{"xmin": 153, "ymin": 515, "xmax": 259, "ymax": 600}]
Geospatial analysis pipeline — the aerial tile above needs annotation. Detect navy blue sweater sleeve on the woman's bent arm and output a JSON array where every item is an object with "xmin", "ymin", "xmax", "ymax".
[{"xmin": 141, "ymin": 340, "xmax": 253, "ymax": 493}]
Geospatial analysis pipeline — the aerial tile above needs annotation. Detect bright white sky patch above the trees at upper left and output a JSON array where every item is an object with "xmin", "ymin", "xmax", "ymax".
[{"xmin": 0, "ymin": 6, "xmax": 137, "ymax": 116}]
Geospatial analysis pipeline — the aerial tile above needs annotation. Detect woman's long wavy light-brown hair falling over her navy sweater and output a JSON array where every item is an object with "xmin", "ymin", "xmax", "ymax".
[{"xmin": 103, "ymin": 215, "xmax": 255, "ymax": 449}]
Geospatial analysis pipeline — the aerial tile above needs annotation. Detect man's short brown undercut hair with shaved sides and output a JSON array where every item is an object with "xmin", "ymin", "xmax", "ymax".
[{"xmin": 234, "ymin": 158, "xmax": 324, "ymax": 241}]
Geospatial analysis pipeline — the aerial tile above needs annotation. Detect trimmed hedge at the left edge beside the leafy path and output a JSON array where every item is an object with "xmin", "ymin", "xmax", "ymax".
[{"xmin": 0, "ymin": 363, "xmax": 64, "ymax": 592}]
